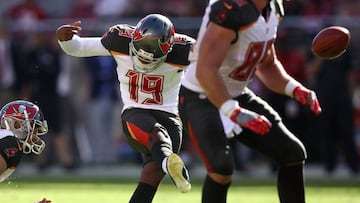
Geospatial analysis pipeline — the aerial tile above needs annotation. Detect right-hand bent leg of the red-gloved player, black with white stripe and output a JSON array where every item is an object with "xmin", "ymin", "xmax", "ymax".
[{"xmin": 236, "ymin": 91, "xmax": 306, "ymax": 203}]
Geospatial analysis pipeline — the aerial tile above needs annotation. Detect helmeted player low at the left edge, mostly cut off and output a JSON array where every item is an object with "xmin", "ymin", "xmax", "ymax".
[{"xmin": 0, "ymin": 100, "xmax": 48, "ymax": 182}]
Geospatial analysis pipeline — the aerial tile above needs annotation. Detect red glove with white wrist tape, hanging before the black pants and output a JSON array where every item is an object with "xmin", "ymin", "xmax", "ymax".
[{"xmin": 220, "ymin": 100, "xmax": 271, "ymax": 135}]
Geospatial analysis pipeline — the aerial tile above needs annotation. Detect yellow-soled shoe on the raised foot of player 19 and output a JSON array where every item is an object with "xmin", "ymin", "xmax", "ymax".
[{"xmin": 167, "ymin": 154, "xmax": 191, "ymax": 193}]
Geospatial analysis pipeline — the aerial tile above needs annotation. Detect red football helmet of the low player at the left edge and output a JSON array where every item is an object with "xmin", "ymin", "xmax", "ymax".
[{"xmin": 0, "ymin": 100, "xmax": 48, "ymax": 154}]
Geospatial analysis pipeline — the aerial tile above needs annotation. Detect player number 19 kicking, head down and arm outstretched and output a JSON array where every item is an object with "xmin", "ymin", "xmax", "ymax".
[{"xmin": 56, "ymin": 14, "xmax": 195, "ymax": 203}]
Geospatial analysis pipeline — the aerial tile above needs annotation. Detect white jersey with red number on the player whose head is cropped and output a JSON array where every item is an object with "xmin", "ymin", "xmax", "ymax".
[{"xmin": 182, "ymin": 0, "xmax": 282, "ymax": 97}]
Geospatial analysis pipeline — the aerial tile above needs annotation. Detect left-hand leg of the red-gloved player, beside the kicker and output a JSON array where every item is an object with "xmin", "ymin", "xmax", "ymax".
[{"xmin": 179, "ymin": 87, "xmax": 234, "ymax": 203}]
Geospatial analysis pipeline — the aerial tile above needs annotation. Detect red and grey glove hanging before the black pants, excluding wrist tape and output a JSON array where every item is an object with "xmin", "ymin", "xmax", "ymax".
[{"xmin": 230, "ymin": 108, "xmax": 271, "ymax": 135}]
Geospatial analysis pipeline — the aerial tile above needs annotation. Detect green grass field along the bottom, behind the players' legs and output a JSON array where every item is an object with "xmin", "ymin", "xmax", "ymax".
[{"xmin": 0, "ymin": 177, "xmax": 360, "ymax": 203}]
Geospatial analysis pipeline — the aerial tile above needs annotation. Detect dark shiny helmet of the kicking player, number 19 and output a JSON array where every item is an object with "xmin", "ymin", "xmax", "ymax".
[{"xmin": 129, "ymin": 14, "xmax": 175, "ymax": 73}]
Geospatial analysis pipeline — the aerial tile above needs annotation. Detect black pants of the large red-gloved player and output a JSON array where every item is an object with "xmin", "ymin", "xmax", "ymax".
[{"xmin": 179, "ymin": 86, "xmax": 306, "ymax": 175}]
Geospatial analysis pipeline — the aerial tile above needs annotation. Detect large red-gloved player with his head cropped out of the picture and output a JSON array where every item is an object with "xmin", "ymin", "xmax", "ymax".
[{"xmin": 179, "ymin": 0, "xmax": 321, "ymax": 203}]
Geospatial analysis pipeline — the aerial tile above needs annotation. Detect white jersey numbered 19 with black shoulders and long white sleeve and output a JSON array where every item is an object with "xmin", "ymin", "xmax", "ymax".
[{"xmin": 59, "ymin": 24, "xmax": 195, "ymax": 114}]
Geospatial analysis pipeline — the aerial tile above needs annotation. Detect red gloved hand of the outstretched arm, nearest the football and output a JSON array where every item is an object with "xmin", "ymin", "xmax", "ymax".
[{"xmin": 293, "ymin": 86, "xmax": 321, "ymax": 115}]
